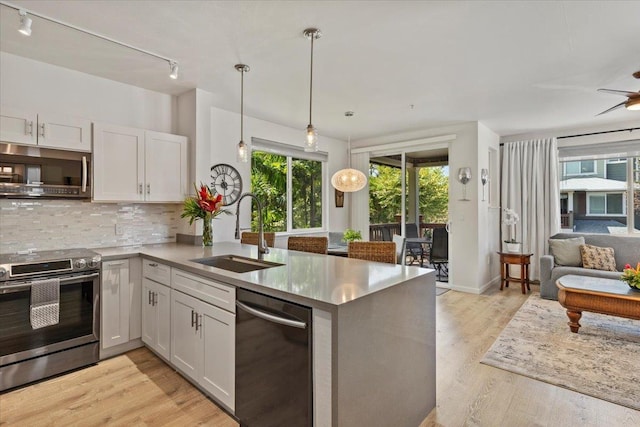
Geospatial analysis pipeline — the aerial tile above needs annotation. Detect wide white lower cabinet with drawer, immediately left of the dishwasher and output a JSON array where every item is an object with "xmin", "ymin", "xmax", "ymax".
[{"xmin": 171, "ymin": 270, "xmax": 235, "ymax": 411}]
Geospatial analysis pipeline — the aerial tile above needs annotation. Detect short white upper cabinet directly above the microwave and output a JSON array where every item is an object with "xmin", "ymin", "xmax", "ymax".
[{"xmin": 0, "ymin": 106, "xmax": 91, "ymax": 152}]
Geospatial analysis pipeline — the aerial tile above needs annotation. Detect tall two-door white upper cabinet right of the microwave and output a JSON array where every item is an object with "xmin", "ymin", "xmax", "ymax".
[{"xmin": 93, "ymin": 123, "xmax": 187, "ymax": 202}]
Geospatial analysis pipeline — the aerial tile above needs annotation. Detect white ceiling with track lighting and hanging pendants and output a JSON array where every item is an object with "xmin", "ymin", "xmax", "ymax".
[{"xmin": 0, "ymin": 0, "xmax": 640, "ymax": 140}]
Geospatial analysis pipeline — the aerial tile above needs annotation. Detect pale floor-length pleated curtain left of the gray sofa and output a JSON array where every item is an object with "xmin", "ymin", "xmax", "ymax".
[{"xmin": 501, "ymin": 138, "xmax": 560, "ymax": 280}]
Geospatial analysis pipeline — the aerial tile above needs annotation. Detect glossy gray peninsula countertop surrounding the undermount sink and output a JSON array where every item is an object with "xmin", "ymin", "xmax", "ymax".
[{"xmin": 93, "ymin": 242, "xmax": 433, "ymax": 309}]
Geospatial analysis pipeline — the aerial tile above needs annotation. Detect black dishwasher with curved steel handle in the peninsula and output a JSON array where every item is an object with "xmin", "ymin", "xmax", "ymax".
[{"xmin": 235, "ymin": 289, "xmax": 313, "ymax": 427}]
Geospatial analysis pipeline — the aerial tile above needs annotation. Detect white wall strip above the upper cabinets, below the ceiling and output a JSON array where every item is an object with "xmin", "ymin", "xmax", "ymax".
[{"xmin": 0, "ymin": 52, "xmax": 176, "ymax": 133}]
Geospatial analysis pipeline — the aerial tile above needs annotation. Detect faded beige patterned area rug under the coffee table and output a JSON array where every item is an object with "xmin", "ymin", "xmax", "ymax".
[{"xmin": 481, "ymin": 293, "xmax": 640, "ymax": 410}]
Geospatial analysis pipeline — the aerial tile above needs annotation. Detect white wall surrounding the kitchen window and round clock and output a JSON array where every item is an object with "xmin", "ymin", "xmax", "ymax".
[{"xmin": 178, "ymin": 89, "xmax": 348, "ymax": 247}]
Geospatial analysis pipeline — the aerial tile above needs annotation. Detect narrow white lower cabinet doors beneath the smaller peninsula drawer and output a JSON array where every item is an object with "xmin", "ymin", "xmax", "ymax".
[{"xmin": 142, "ymin": 277, "xmax": 171, "ymax": 360}]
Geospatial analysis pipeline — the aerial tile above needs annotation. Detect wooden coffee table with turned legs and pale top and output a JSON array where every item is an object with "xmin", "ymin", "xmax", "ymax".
[{"xmin": 556, "ymin": 274, "xmax": 640, "ymax": 333}]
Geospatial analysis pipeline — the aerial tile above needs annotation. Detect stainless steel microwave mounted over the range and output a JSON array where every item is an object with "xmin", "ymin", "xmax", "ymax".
[{"xmin": 0, "ymin": 143, "xmax": 91, "ymax": 199}]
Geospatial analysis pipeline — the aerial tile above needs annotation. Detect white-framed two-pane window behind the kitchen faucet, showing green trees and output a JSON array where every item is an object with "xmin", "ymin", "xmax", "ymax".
[{"xmin": 251, "ymin": 138, "xmax": 326, "ymax": 232}]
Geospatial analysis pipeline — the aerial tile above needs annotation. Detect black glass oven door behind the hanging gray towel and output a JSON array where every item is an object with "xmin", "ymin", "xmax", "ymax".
[{"xmin": 0, "ymin": 272, "xmax": 100, "ymax": 367}]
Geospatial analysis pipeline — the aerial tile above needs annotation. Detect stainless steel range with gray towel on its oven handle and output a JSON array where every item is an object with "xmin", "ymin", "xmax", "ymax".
[{"xmin": 0, "ymin": 249, "xmax": 101, "ymax": 391}]
